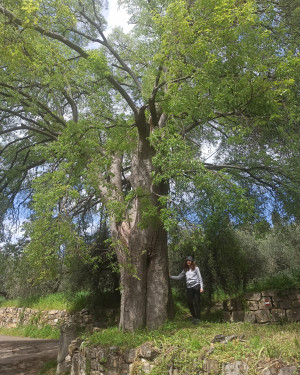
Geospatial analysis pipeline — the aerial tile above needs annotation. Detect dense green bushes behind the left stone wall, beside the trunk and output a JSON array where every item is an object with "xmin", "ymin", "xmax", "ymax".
[{"xmin": 0, "ymin": 216, "xmax": 119, "ymax": 298}]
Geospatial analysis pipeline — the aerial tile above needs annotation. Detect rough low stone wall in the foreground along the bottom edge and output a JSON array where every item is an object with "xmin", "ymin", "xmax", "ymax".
[{"xmin": 68, "ymin": 339, "xmax": 300, "ymax": 375}]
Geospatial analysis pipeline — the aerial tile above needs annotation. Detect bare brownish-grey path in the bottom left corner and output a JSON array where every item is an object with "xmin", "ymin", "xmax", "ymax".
[{"xmin": 0, "ymin": 335, "xmax": 58, "ymax": 375}]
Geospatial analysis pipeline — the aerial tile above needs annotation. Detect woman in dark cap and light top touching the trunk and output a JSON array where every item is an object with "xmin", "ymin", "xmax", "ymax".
[{"xmin": 170, "ymin": 256, "xmax": 204, "ymax": 324}]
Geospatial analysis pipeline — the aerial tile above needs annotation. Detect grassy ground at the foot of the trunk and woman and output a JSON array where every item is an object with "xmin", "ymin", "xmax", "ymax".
[{"xmin": 85, "ymin": 319, "xmax": 300, "ymax": 375}]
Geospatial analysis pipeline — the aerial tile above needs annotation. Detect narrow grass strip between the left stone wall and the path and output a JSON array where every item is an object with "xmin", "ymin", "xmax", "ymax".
[{"xmin": 0, "ymin": 325, "xmax": 60, "ymax": 339}]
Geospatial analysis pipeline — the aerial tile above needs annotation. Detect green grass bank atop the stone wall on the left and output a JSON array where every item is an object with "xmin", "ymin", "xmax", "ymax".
[{"xmin": 0, "ymin": 292, "xmax": 90, "ymax": 312}]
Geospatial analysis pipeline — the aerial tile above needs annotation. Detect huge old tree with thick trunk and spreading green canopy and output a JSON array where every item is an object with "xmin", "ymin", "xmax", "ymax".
[{"xmin": 0, "ymin": 0, "xmax": 299, "ymax": 330}]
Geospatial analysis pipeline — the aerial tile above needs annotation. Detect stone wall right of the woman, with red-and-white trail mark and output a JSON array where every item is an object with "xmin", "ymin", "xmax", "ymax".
[{"xmin": 223, "ymin": 288, "xmax": 300, "ymax": 323}]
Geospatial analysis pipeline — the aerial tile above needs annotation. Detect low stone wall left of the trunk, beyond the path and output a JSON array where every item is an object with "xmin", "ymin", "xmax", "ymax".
[{"xmin": 0, "ymin": 307, "xmax": 115, "ymax": 329}]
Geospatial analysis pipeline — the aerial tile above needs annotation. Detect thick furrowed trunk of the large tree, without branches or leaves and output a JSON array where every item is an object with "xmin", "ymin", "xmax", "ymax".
[{"xmin": 111, "ymin": 112, "xmax": 173, "ymax": 331}]
